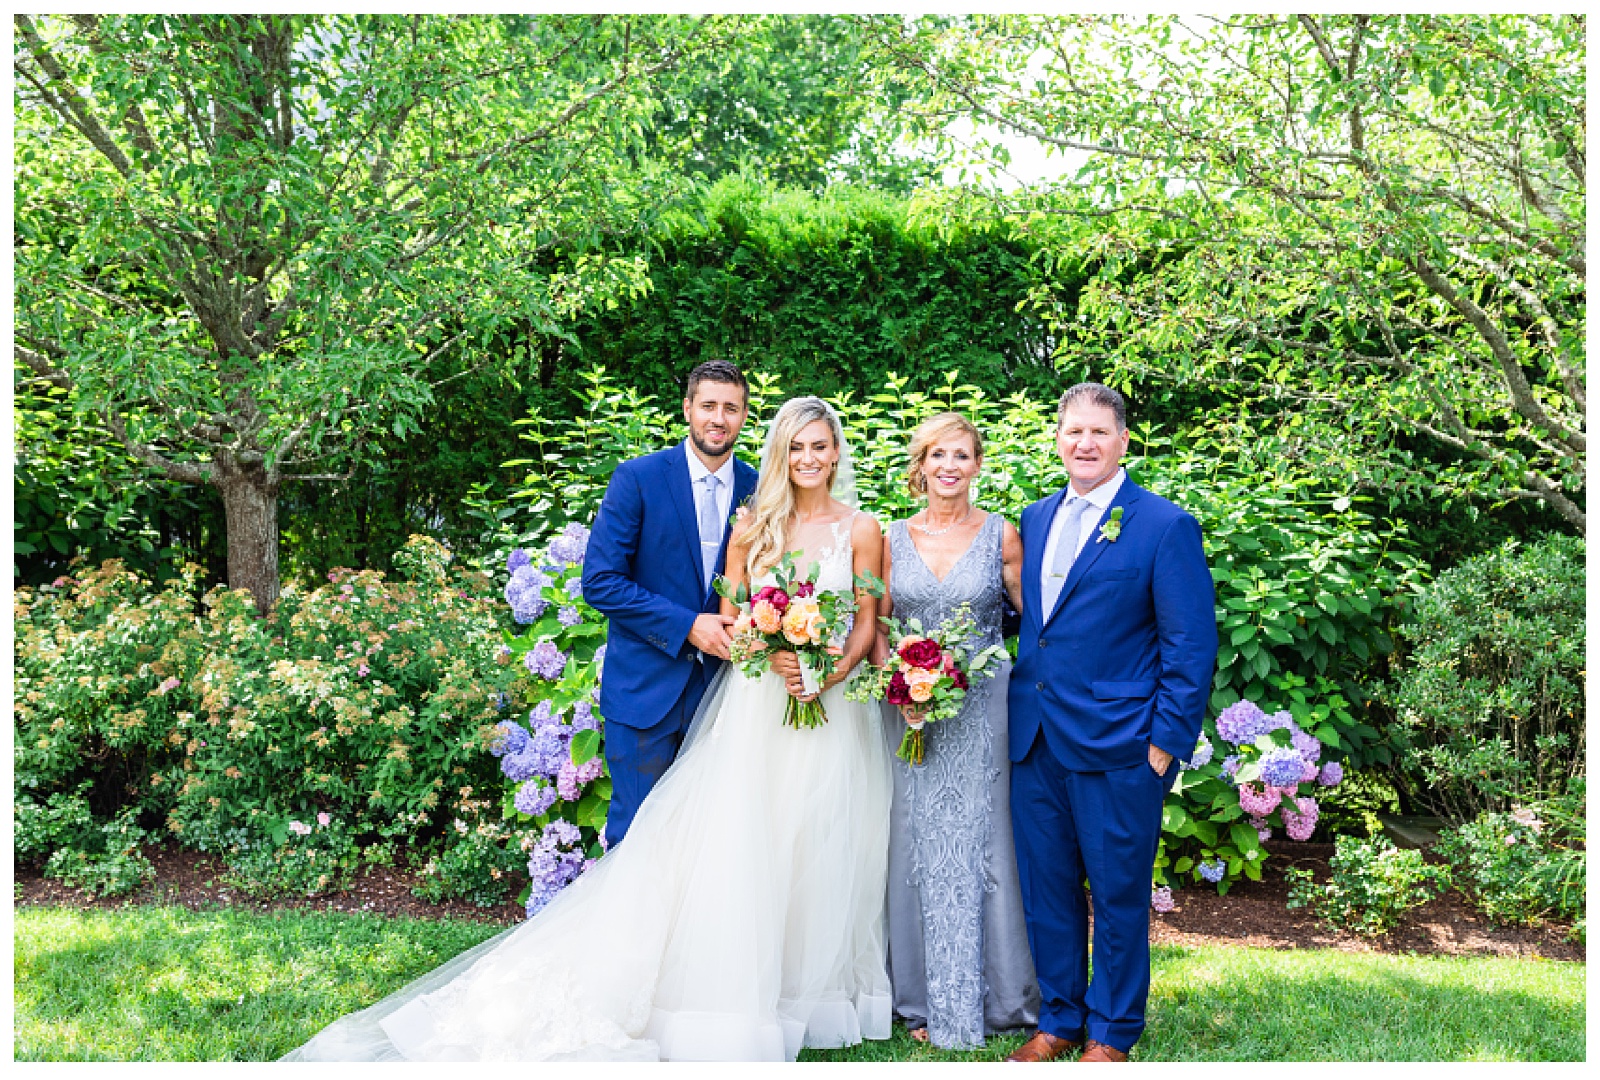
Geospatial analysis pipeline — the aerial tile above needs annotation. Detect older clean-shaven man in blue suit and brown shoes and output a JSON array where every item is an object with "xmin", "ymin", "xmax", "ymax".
[{"xmin": 1008, "ymin": 382, "xmax": 1216, "ymax": 1061}]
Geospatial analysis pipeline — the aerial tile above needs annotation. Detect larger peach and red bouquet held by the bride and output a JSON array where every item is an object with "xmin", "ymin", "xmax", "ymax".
[{"xmin": 715, "ymin": 552, "xmax": 885, "ymax": 728}]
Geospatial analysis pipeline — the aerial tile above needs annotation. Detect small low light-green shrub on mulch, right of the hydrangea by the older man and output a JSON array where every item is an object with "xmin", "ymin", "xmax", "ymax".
[{"xmin": 1286, "ymin": 837, "xmax": 1450, "ymax": 936}]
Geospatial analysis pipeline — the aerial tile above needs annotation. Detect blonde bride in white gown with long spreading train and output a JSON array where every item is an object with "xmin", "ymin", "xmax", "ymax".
[{"xmin": 286, "ymin": 398, "xmax": 893, "ymax": 1061}]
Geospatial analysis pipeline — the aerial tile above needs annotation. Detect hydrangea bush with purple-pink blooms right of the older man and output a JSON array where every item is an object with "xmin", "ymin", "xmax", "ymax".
[{"xmin": 1155, "ymin": 675, "xmax": 1344, "ymax": 893}]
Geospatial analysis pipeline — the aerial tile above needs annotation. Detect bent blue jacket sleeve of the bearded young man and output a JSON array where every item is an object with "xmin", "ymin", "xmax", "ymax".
[{"xmin": 582, "ymin": 467, "xmax": 699, "ymax": 656}]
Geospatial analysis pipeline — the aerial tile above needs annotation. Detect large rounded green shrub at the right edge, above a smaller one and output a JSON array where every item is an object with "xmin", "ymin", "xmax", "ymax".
[{"xmin": 1389, "ymin": 536, "xmax": 1586, "ymax": 822}]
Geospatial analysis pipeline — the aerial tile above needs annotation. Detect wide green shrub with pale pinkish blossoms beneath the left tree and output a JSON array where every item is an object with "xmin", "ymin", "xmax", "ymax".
[{"xmin": 14, "ymin": 538, "xmax": 507, "ymax": 880}]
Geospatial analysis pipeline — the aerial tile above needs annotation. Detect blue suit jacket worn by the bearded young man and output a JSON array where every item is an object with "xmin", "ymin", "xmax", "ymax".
[{"xmin": 582, "ymin": 443, "xmax": 757, "ymax": 728}]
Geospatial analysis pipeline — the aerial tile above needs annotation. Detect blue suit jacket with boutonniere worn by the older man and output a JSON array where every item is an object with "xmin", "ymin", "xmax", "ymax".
[{"xmin": 1008, "ymin": 477, "xmax": 1216, "ymax": 773}]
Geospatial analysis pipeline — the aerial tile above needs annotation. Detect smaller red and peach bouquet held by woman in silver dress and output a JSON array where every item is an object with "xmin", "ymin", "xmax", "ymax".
[{"xmin": 846, "ymin": 603, "xmax": 1005, "ymax": 765}]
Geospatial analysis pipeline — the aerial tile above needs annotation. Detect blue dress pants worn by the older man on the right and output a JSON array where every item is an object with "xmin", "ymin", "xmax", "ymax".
[{"xmin": 1011, "ymin": 730, "xmax": 1178, "ymax": 1051}]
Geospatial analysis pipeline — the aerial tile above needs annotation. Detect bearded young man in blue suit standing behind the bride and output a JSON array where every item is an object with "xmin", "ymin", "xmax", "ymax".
[{"xmin": 582, "ymin": 360, "xmax": 755, "ymax": 843}]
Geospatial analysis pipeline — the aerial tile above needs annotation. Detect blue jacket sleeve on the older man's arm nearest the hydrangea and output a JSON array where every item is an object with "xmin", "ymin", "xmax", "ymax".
[{"xmin": 1150, "ymin": 514, "xmax": 1216, "ymax": 760}]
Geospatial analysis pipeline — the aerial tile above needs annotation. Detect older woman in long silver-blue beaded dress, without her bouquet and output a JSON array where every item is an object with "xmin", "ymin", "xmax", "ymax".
[{"xmin": 874, "ymin": 413, "xmax": 1038, "ymax": 1050}]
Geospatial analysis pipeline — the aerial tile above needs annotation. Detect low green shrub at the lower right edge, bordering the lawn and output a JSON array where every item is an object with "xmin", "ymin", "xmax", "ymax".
[{"xmin": 1437, "ymin": 790, "xmax": 1586, "ymax": 925}]
